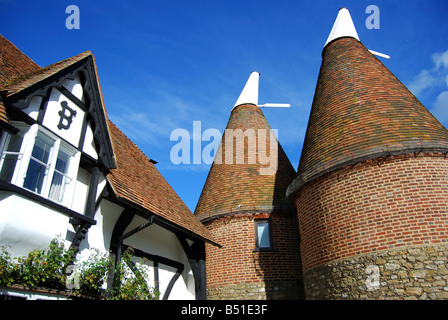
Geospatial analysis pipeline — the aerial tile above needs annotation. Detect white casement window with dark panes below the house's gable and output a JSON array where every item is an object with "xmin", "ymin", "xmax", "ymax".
[{"xmin": 0, "ymin": 124, "xmax": 80, "ymax": 206}]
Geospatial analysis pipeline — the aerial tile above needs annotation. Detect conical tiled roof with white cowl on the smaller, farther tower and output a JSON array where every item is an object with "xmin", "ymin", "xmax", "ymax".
[{"xmin": 195, "ymin": 73, "xmax": 296, "ymax": 220}]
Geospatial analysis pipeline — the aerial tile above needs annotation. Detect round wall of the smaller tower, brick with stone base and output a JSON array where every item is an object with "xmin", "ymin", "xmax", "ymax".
[{"xmin": 206, "ymin": 211, "xmax": 303, "ymax": 299}]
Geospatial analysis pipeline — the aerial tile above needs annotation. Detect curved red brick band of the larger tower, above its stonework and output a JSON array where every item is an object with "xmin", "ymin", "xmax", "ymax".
[{"xmin": 295, "ymin": 154, "xmax": 448, "ymax": 271}]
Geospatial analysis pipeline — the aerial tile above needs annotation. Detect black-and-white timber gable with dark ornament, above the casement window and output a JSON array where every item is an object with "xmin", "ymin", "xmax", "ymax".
[{"xmin": 3, "ymin": 52, "xmax": 116, "ymax": 170}]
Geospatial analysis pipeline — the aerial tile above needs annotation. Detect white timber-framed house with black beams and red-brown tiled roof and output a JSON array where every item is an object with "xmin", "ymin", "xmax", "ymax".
[{"xmin": 0, "ymin": 35, "xmax": 216, "ymax": 299}]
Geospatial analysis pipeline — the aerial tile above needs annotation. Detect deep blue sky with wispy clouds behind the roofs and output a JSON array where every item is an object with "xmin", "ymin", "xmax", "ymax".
[{"xmin": 0, "ymin": 0, "xmax": 448, "ymax": 211}]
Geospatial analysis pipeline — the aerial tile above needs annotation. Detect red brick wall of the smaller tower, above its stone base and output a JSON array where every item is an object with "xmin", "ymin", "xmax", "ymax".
[{"xmin": 206, "ymin": 212, "xmax": 302, "ymax": 287}]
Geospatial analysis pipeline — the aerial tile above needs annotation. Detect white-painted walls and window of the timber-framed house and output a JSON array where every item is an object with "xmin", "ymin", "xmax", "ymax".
[{"xmin": 0, "ymin": 67, "xmax": 200, "ymax": 299}]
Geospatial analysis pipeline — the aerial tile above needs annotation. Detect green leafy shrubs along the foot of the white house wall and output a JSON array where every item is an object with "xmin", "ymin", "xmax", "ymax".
[{"xmin": 0, "ymin": 238, "xmax": 159, "ymax": 300}]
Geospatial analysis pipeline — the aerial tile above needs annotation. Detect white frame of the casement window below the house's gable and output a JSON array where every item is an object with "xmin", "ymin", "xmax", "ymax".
[{"xmin": 0, "ymin": 123, "xmax": 81, "ymax": 207}]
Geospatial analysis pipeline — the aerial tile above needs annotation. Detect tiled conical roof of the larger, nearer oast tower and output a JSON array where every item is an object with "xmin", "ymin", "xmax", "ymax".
[{"xmin": 287, "ymin": 8, "xmax": 448, "ymax": 195}]
